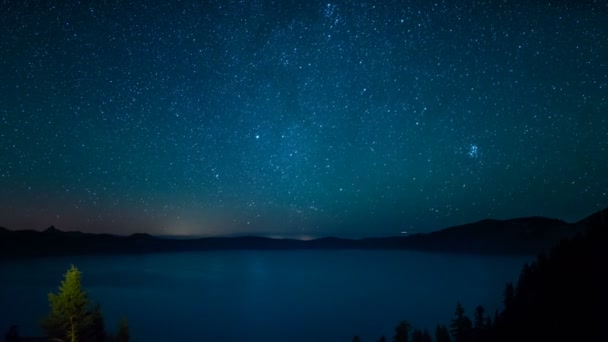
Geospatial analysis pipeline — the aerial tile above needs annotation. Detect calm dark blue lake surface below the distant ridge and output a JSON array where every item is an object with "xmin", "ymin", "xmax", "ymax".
[{"xmin": 0, "ymin": 251, "xmax": 532, "ymax": 342}]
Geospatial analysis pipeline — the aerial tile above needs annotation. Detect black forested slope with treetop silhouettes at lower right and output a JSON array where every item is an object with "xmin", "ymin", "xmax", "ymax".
[{"xmin": 353, "ymin": 210, "xmax": 608, "ymax": 342}]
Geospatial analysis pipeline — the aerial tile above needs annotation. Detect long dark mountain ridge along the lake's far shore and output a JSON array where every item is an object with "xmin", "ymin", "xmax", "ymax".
[{"xmin": 0, "ymin": 209, "xmax": 608, "ymax": 258}]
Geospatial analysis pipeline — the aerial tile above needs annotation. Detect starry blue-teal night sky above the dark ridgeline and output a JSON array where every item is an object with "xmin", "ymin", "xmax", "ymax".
[{"xmin": 0, "ymin": 0, "xmax": 608, "ymax": 238}]
